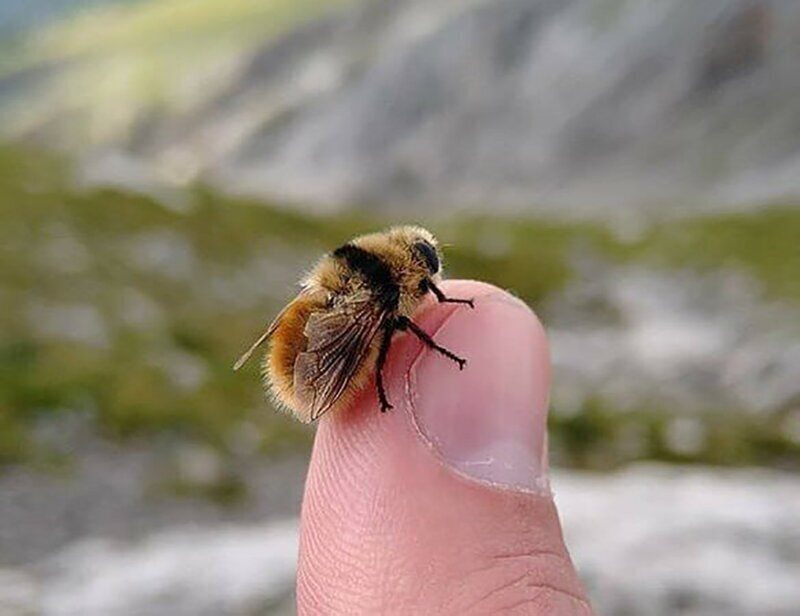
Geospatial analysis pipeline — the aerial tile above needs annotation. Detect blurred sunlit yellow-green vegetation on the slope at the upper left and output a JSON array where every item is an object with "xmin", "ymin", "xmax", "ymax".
[{"xmin": 0, "ymin": 0, "xmax": 347, "ymax": 145}]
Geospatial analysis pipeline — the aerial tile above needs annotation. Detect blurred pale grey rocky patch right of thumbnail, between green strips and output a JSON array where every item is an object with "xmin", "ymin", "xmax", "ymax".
[{"xmin": 546, "ymin": 259, "xmax": 800, "ymax": 415}]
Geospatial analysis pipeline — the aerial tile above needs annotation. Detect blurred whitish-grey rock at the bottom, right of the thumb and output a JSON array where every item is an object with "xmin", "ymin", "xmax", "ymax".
[{"xmin": 553, "ymin": 466, "xmax": 800, "ymax": 616}]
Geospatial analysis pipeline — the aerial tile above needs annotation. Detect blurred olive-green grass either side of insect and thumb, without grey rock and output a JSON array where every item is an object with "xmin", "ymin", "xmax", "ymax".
[{"xmin": 0, "ymin": 148, "xmax": 800, "ymax": 472}]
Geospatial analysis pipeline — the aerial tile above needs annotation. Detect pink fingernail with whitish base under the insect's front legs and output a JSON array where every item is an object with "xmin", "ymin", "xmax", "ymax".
[{"xmin": 409, "ymin": 291, "xmax": 550, "ymax": 493}]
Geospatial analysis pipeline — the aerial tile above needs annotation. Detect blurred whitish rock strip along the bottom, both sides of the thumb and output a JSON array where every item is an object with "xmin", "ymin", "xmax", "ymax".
[{"xmin": 0, "ymin": 466, "xmax": 800, "ymax": 616}]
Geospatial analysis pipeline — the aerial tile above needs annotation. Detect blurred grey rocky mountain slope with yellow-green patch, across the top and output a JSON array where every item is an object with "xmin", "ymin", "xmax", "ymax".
[{"xmin": 0, "ymin": 0, "xmax": 800, "ymax": 217}]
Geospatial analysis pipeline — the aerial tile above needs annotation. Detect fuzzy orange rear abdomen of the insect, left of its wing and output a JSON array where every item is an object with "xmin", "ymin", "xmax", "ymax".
[{"xmin": 265, "ymin": 297, "xmax": 324, "ymax": 408}]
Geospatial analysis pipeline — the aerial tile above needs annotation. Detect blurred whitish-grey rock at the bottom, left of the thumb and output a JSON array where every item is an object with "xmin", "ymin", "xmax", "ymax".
[{"xmin": 0, "ymin": 521, "xmax": 297, "ymax": 616}]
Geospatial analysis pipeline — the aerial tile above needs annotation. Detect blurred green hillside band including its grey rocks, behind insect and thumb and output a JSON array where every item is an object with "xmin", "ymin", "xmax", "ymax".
[{"xmin": 0, "ymin": 149, "xmax": 800, "ymax": 468}]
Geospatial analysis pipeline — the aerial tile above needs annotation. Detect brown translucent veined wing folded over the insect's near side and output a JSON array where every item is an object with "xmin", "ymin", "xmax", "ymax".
[{"xmin": 294, "ymin": 291, "xmax": 389, "ymax": 421}]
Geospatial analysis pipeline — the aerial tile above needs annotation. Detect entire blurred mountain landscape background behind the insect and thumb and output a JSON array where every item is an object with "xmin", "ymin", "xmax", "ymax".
[{"xmin": 0, "ymin": 0, "xmax": 800, "ymax": 616}]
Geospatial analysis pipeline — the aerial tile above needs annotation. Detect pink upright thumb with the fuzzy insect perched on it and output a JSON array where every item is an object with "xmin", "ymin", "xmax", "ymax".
[{"xmin": 297, "ymin": 281, "xmax": 591, "ymax": 615}]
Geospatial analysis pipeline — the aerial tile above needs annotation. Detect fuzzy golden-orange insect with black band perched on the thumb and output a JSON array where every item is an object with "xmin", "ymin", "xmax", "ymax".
[{"xmin": 234, "ymin": 226, "xmax": 474, "ymax": 422}]
